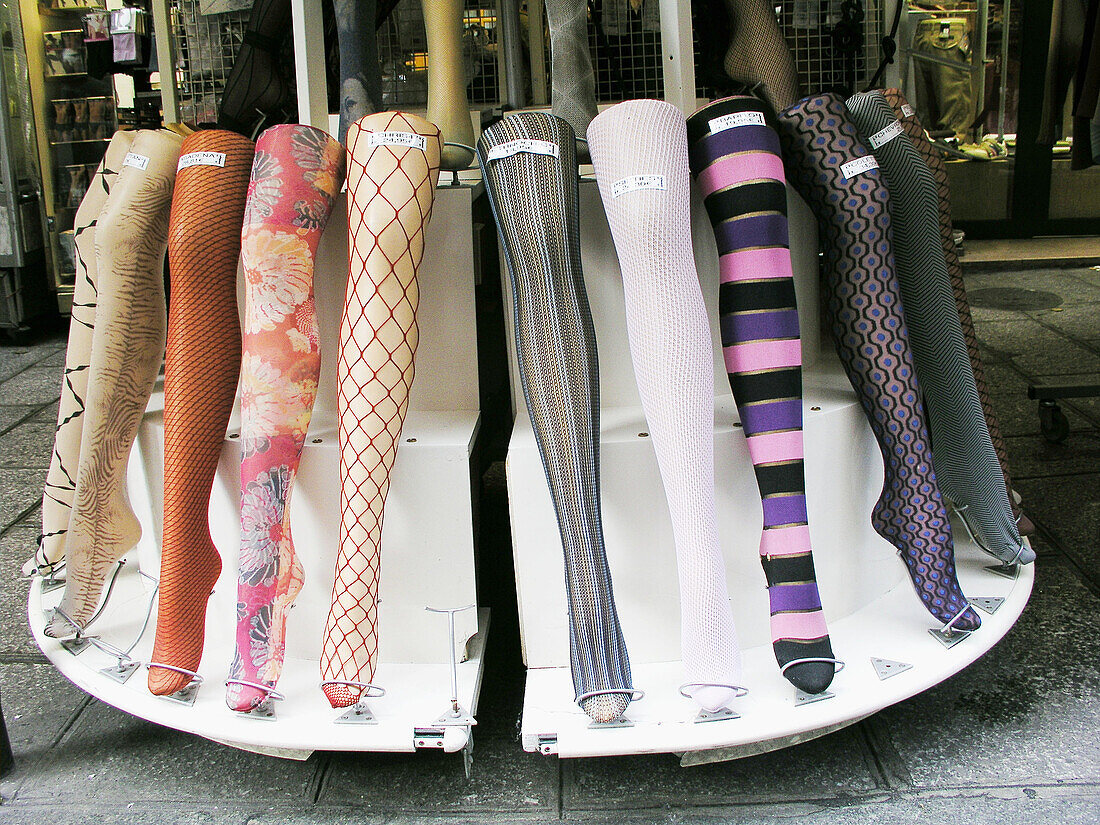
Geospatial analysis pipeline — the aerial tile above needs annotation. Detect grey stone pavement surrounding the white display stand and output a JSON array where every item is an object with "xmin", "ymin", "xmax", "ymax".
[{"xmin": 0, "ymin": 267, "xmax": 1100, "ymax": 825}]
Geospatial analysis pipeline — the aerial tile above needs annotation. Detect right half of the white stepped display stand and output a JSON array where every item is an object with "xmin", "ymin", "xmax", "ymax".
[{"xmin": 502, "ymin": 178, "xmax": 1034, "ymax": 758}]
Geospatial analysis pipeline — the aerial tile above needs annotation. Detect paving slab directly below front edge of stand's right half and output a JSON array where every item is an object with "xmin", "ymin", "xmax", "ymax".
[{"xmin": 562, "ymin": 727, "xmax": 878, "ymax": 812}]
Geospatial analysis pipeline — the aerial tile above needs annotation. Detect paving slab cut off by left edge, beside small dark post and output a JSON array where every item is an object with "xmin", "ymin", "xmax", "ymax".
[{"xmin": 0, "ymin": 662, "xmax": 88, "ymax": 800}]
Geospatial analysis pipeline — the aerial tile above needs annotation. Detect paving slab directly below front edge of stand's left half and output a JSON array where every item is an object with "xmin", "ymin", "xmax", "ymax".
[{"xmin": 20, "ymin": 700, "xmax": 321, "ymax": 816}]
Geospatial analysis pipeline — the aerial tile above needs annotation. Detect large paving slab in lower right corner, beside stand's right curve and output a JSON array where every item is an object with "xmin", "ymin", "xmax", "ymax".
[{"xmin": 869, "ymin": 560, "xmax": 1100, "ymax": 789}]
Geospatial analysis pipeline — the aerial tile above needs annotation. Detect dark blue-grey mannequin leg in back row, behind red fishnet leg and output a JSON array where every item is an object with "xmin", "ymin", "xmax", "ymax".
[{"xmin": 333, "ymin": 0, "xmax": 382, "ymax": 141}]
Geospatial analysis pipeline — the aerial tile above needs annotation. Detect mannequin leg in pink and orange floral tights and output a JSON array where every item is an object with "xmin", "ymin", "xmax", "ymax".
[{"xmin": 226, "ymin": 125, "xmax": 344, "ymax": 711}]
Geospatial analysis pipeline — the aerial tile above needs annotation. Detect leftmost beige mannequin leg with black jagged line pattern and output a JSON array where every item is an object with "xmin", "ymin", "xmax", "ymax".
[{"xmin": 36, "ymin": 132, "xmax": 135, "ymax": 571}]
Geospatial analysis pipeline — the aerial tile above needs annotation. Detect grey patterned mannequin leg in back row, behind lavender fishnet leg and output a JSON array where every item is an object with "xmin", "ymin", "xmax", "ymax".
[{"xmin": 546, "ymin": 0, "xmax": 597, "ymax": 155}]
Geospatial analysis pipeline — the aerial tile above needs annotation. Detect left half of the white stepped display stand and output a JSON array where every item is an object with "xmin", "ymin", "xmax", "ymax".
[{"xmin": 30, "ymin": 184, "xmax": 488, "ymax": 759}]
